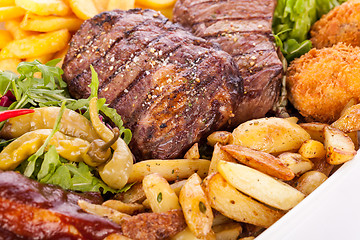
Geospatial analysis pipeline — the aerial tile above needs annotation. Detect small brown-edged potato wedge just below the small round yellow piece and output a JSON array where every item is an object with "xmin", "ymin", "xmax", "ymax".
[{"xmin": 279, "ymin": 150, "xmax": 314, "ymax": 176}]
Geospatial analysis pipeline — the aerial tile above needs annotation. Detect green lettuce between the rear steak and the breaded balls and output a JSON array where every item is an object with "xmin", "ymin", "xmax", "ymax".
[{"xmin": 273, "ymin": 0, "xmax": 346, "ymax": 61}]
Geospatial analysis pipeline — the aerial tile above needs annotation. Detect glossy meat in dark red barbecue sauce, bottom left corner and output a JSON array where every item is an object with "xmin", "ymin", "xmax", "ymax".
[{"xmin": 0, "ymin": 171, "xmax": 121, "ymax": 240}]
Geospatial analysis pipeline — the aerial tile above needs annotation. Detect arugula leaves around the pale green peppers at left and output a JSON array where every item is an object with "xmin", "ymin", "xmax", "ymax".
[{"xmin": 0, "ymin": 59, "xmax": 132, "ymax": 193}]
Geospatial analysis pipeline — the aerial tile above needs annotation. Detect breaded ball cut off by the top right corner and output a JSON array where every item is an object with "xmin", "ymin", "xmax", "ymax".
[{"xmin": 310, "ymin": 0, "xmax": 360, "ymax": 48}]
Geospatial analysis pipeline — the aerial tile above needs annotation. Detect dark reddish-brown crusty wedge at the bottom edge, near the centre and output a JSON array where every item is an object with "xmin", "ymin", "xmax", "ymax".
[{"xmin": 121, "ymin": 210, "xmax": 186, "ymax": 240}]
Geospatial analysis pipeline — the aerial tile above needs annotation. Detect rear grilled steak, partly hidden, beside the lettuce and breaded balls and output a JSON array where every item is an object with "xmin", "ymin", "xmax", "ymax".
[{"xmin": 174, "ymin": 0, "xmax": 282, "ymax": 119}]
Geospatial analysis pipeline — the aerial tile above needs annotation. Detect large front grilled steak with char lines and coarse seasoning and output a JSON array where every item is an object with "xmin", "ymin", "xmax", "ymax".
[{"xmin": 63, "ymin": 9, "xmax": 243, "ymax": 159}]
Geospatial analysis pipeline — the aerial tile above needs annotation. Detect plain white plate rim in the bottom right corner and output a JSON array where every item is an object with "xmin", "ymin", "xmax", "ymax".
[{"xmin": 256, "ymin": 151, "xmax": 360, "ymax": 240}]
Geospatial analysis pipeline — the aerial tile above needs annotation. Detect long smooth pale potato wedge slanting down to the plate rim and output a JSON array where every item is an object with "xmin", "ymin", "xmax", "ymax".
[{"xmin": 218, "ymin": 161, "xmax": 305, "ymax": 210}]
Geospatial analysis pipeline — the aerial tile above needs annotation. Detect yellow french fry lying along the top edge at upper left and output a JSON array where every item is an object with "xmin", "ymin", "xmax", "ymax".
[{"xmin": 15, "ymin": 0, "xmax": 70, "ymax": 16}]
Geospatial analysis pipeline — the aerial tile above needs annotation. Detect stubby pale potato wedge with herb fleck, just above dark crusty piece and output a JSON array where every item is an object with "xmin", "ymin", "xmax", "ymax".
[{"xmin": 143, "ymin": 173, "xmax": 180, "ymax": 213}]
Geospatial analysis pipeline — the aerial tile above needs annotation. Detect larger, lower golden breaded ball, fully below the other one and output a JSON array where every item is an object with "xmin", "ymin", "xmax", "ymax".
[{"xmin": 287, "ymin": 43, "xmax": 360, "ymax": 123}]
